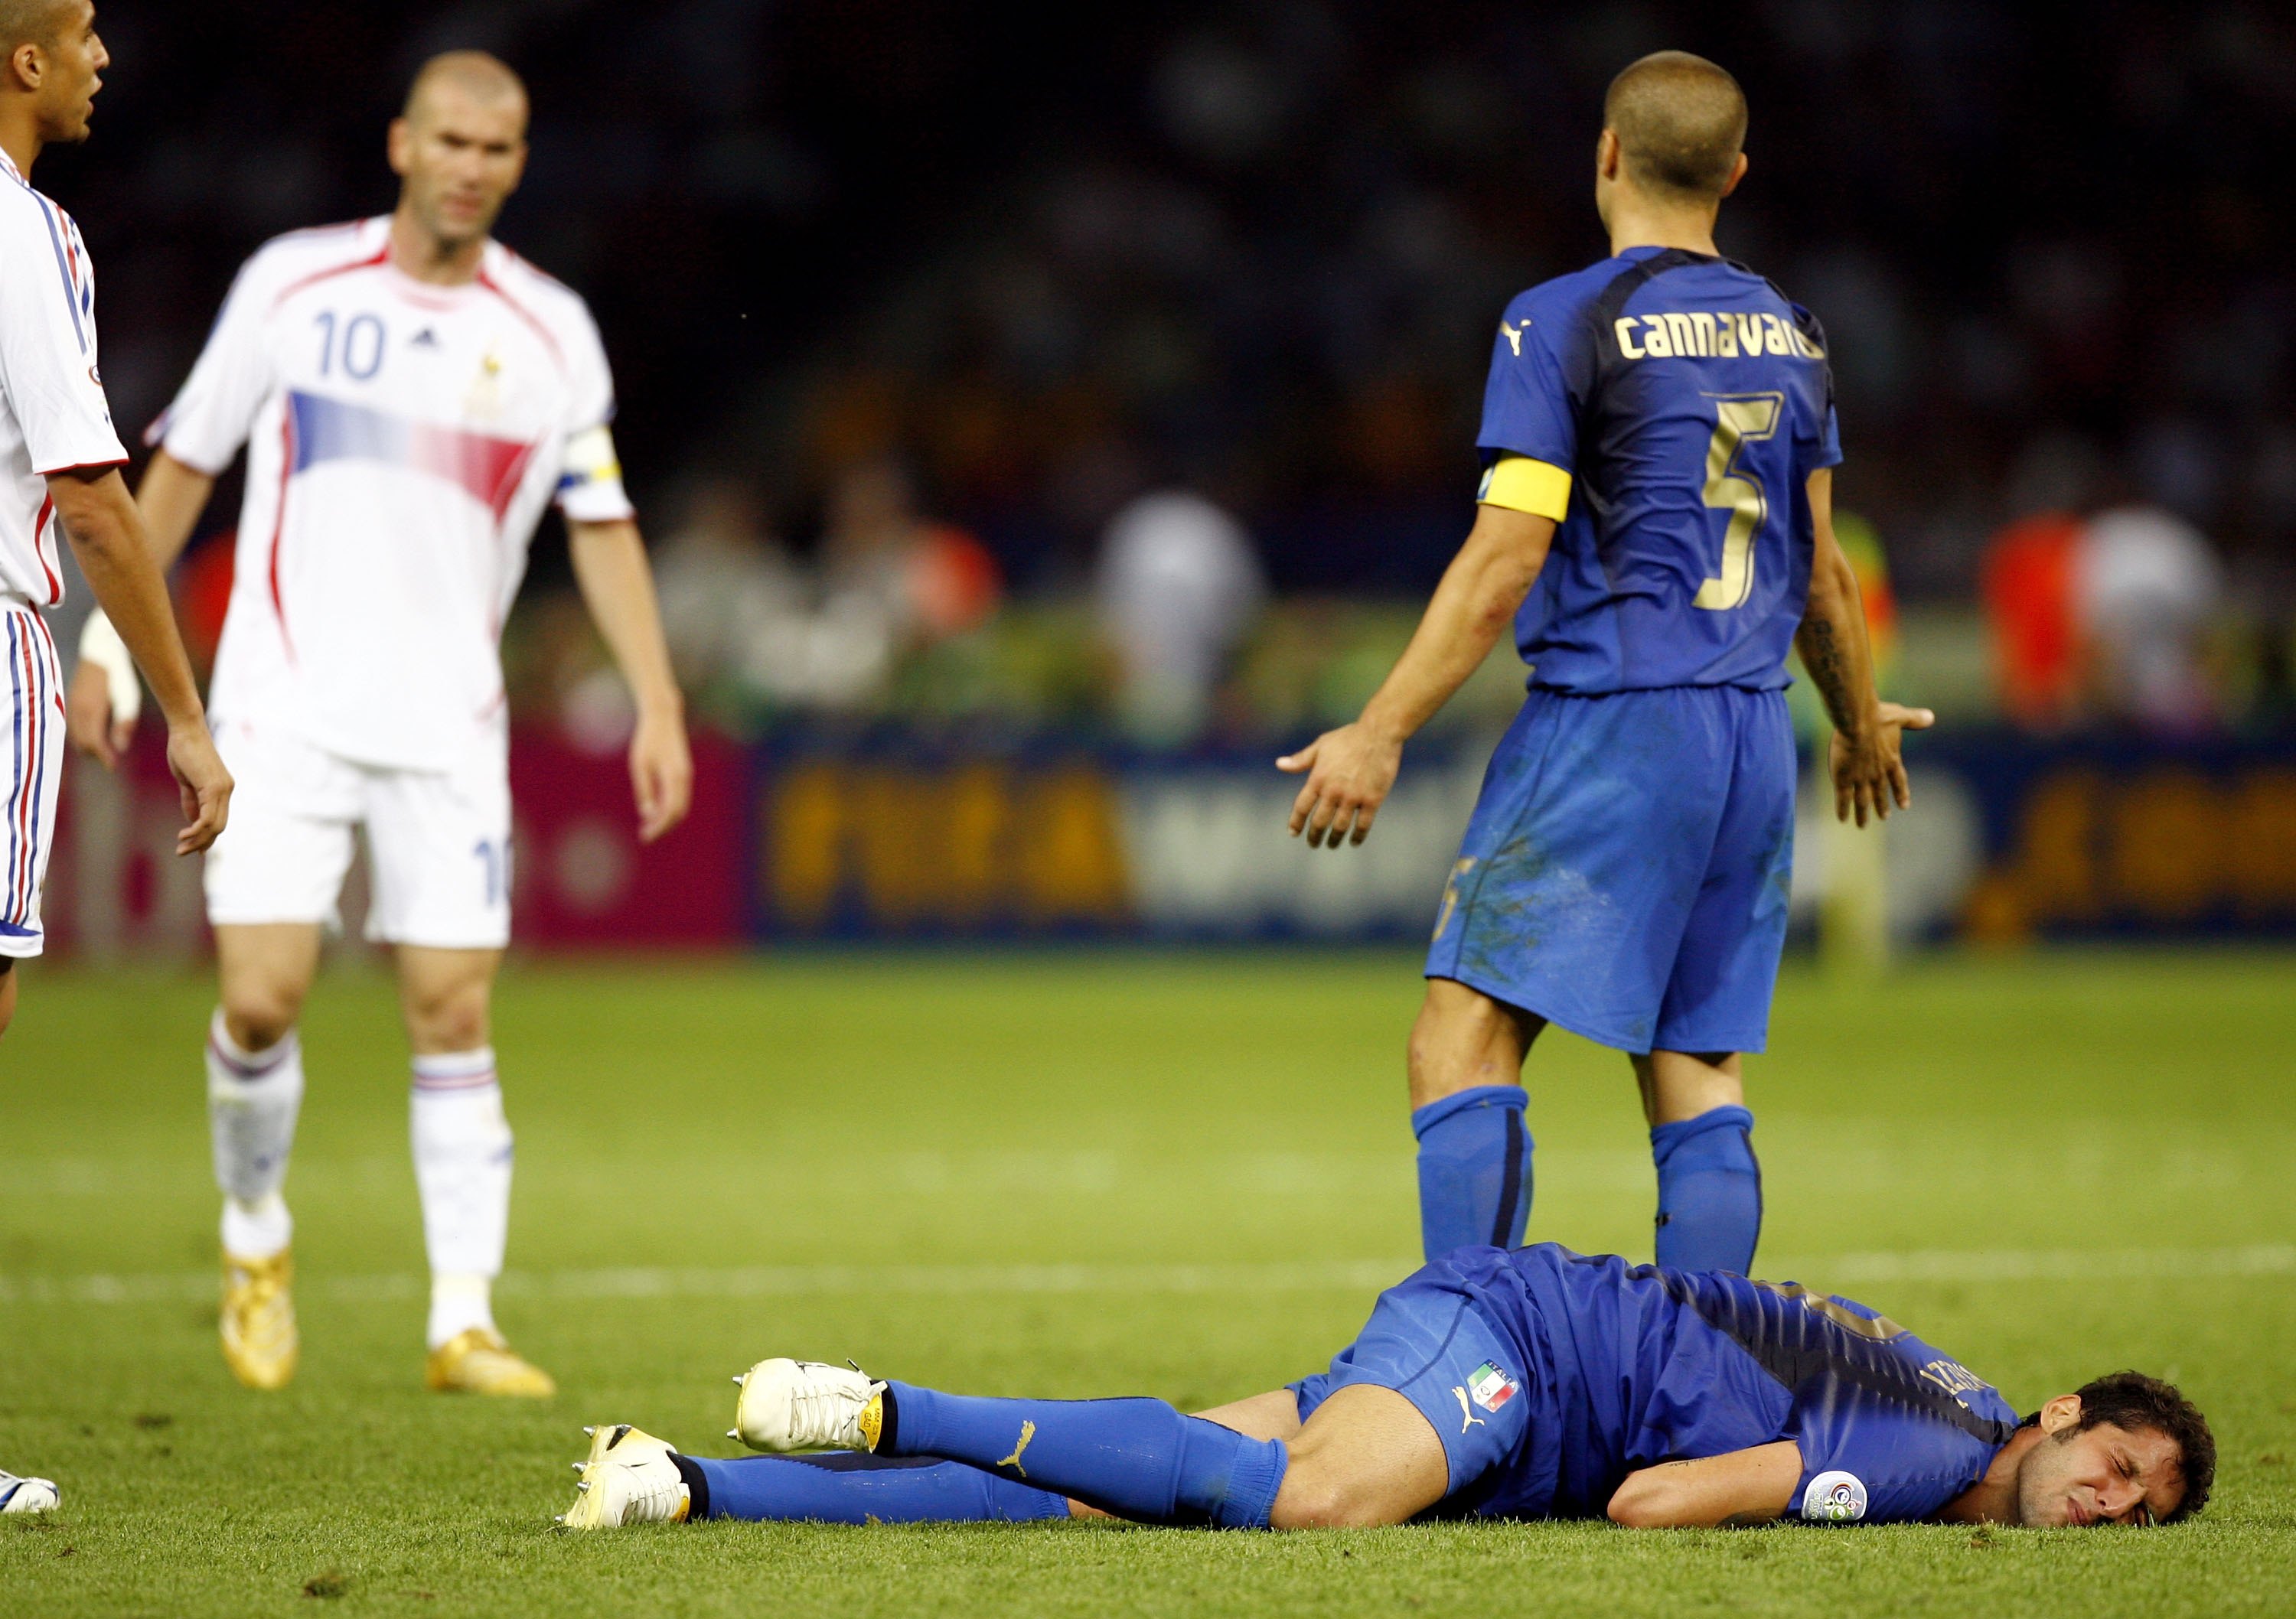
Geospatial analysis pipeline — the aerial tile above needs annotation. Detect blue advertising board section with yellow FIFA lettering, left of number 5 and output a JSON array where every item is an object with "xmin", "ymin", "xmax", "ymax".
[{"xmin": 753, "ymin": 741, "xmax": 1481, "ymax": 940}]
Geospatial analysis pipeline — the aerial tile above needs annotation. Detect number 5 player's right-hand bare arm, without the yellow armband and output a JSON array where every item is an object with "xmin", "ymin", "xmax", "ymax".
[{"xmin": 1793, "ymin": 466, "xmax": 1938, "ymax": 827}]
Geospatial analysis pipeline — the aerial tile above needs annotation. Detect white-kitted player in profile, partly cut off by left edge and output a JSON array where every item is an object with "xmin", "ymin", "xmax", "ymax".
[{"xmin": 0, "ymin": 0, "xmax": 232, "ymax": 1513}]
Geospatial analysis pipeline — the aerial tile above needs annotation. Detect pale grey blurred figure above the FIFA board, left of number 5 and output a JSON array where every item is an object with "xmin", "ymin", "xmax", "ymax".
[{"xmin": 1100, "ymin": 489, "xmax": 1267, "ymax": 741}]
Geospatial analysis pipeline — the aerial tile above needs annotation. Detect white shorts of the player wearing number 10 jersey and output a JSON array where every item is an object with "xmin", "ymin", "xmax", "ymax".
[{"xmin": 207, "ymin": 721, "xmax": 510, "ymax": 951}]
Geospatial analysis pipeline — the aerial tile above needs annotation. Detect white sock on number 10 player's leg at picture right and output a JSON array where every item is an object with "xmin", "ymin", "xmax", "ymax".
[{"xmin": 411, "ymin": 1047, "xmax": 510, "ymax": 1348}]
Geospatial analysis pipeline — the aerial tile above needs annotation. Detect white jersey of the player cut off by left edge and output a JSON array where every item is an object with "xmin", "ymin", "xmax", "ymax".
[{"xmin": 0, "ymin": 151, "xmax": 129, "ymax": 606}]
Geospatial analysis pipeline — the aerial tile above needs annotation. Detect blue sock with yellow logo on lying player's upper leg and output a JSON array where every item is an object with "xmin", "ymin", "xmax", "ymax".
[{"xmin": 877, "ymin": 1383, "xmax": 1288, "ymax": 1529}]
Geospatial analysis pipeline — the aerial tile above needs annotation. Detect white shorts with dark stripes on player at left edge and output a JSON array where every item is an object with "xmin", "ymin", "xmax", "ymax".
[{"xmin": 0, "ymin": 599, "xmax": 64, "ymax": 960}]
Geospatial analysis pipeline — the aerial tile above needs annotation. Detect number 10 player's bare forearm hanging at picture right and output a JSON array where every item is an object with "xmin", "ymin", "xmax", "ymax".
[{"xmin": 567, "ymin": 516, "xmax": 693, "ymax": 843}]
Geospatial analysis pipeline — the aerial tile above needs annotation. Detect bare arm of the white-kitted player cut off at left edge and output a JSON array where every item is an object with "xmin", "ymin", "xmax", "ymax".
[{"xmin": 48, "ymin": 466, "xmax": 232, "ymax": 855}]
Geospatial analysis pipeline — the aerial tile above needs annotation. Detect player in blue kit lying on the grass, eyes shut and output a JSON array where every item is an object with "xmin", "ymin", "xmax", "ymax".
[{"xmin": 560, "ymin": 1243, "xmax": 2216, "ymax": 1529}]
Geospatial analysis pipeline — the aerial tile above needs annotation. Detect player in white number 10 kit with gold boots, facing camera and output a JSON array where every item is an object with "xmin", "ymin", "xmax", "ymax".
[{"xmin": 71, "ymin": 53, "xmax": 693, "ymax": 1396}]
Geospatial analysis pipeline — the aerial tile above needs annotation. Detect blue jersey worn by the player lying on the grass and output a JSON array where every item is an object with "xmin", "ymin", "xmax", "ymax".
[{"xmin": 1442, "ymin": 1243, "xmax": 2018, "ymax": 1523}]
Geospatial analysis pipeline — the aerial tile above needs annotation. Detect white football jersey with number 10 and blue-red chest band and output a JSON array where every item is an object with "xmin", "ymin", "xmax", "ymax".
[{"xmin": 147, "ymin": 216, "xmax": 631, "ymax": 769}]
